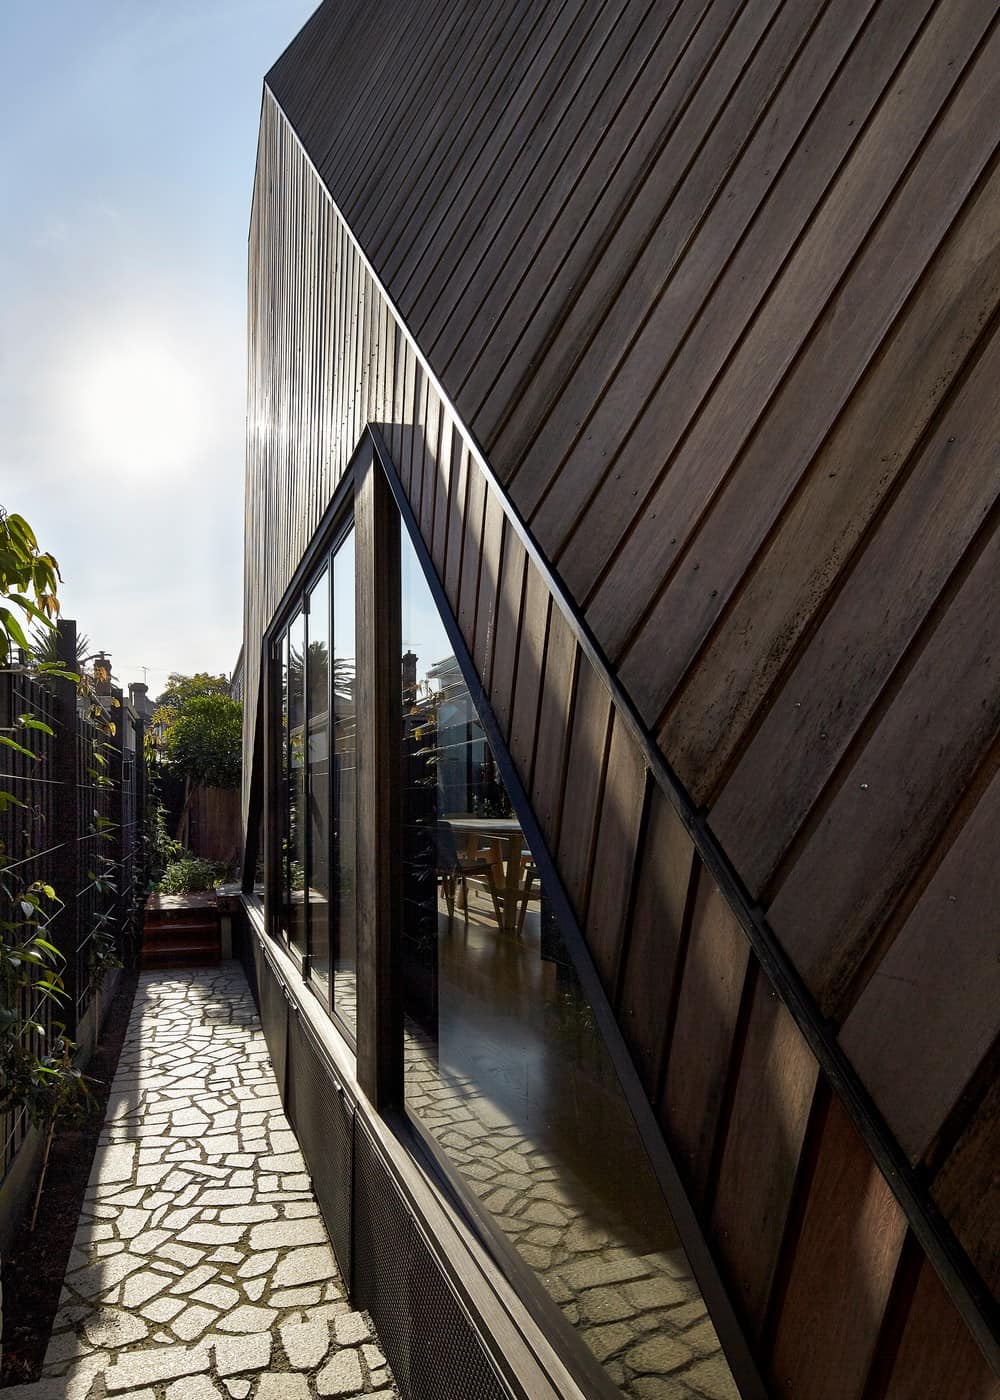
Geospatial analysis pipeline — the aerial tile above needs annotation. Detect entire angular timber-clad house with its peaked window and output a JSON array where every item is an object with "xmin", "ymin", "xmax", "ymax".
[{"xmin": 241, "ymin": 0, "xmax": 1000, "ymax": 1400}]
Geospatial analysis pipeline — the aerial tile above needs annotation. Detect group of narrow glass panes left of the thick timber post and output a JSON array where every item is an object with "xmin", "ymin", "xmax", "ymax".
[{"xmin": 273, "ymin": 526, "xmax": 357, "ymax": 1037}]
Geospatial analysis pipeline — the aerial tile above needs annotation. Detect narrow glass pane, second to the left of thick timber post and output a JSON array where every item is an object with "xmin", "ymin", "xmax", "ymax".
[{"xmin": 305, "ymin": 568, "xmax": 331, "ymax": 1004}]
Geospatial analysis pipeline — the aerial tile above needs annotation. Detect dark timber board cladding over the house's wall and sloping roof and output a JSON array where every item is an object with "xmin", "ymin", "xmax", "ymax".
[{"xmin": 245, "ymin": 0, "xmax": 1000, "ymax": 1400}]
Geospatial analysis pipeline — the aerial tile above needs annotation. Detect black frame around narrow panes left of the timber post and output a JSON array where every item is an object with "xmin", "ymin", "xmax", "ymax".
[{"xmin": 265, "ymin": 492, "xmax": 357, "ymax": 1051}]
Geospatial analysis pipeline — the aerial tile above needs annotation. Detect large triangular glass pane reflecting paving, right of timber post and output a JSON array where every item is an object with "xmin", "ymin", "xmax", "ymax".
[{"xmin": 402, "ymin": 529, "xmax": 738, "ymax": 1400}]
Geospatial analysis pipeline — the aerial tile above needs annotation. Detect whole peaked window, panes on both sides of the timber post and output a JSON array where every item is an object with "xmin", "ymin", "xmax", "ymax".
[{"xmin": 260, "ymin": 458, "xmax": 738, "ymax": 1400}]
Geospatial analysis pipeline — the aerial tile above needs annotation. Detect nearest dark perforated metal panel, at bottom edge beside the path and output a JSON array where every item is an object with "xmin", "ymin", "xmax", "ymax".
[{"xmin": 354, "ymin": 1120, "xmax": 511, "ymax": 1400}]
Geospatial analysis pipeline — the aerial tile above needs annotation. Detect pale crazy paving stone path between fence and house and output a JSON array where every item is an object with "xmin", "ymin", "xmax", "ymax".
[{"xmin": 4, "ymin": 963, "xmax": 396, "ymax": 1400}]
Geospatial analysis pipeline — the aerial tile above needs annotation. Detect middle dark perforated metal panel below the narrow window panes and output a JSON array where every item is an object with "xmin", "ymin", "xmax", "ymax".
[{"xmin": 287, "ymin": 1012, "xmax": 354, "ymax": 1289}]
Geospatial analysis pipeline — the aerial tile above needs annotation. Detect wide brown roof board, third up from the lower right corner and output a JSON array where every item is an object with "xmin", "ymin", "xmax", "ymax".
[{"xmin": 769, "ymin": 515, "xmax": 1000, "ymax": 1015}]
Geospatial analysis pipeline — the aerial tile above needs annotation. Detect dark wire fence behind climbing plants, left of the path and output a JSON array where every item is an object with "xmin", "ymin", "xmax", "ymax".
[{"xmin": 0, "ymin": 623, "xmax": 146, "ymax": 1180}]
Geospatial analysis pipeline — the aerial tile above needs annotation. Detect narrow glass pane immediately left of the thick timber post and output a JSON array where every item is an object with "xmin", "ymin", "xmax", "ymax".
[{"xmin": 333, "ymin": 529, "xmax": 357, "ymax": 1032}]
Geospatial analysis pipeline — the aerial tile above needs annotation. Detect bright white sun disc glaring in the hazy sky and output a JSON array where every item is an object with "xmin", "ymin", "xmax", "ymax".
[{"xmin": 74, "ymin": 337, "xmax": 209, "ymax": 479}]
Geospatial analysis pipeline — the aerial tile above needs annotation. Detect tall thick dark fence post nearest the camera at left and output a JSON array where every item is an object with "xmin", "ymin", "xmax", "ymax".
[{"xmin": 52, "ymin": 619, "xmax": 81, "ymax": 1039}]
